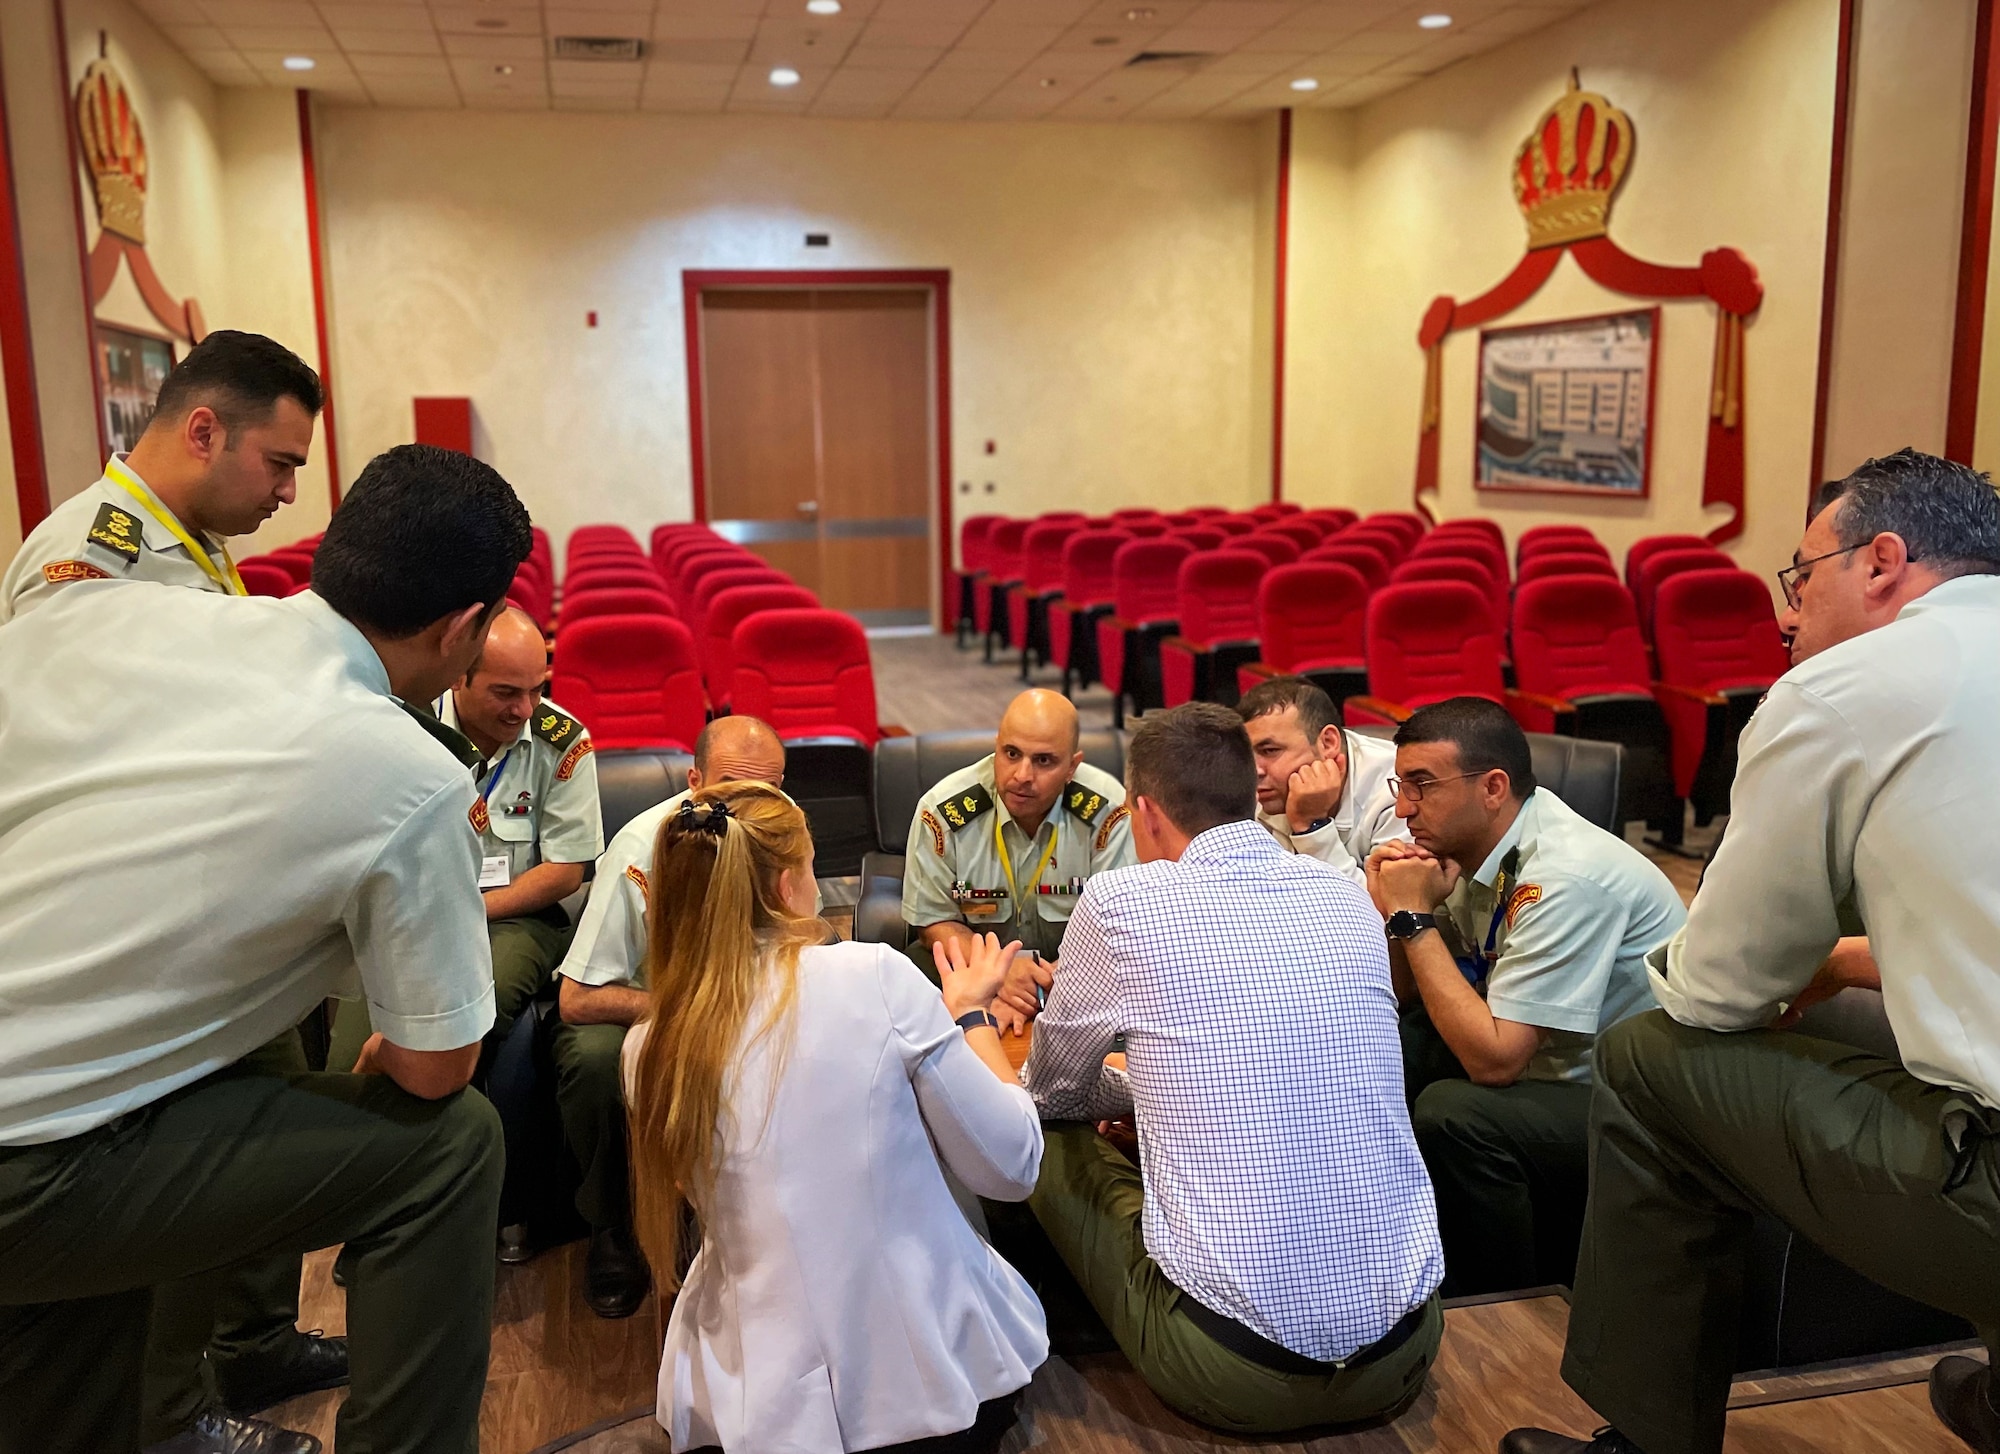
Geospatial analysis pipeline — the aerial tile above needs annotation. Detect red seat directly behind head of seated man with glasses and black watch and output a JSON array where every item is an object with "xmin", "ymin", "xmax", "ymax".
[{"xmin": 1346, "ymin": 580, "xmax": 1558, "ymax": 724}]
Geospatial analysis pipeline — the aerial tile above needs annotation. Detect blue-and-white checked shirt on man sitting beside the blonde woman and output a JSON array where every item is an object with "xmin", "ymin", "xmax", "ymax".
[{"xmin": 1022, "ymin": 820, "xmax": 1444, "ymax": 1362}]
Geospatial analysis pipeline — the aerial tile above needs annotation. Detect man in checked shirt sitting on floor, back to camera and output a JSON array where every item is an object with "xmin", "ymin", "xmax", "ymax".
[{"xmin": 1022, "ymin": 702, "xmax": 1444, "ymax": 1434}]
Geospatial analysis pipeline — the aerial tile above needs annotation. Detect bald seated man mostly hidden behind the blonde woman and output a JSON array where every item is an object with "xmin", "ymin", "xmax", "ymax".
[{"xmin": 554, "ymin": 716, "xmax": 784, "ymax": 1318}]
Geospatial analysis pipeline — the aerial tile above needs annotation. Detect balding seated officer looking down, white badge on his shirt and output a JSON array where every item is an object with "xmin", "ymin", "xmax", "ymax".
[{"xmin": 328, "ymin": 608, "xmax": 604, "ymax": 1068}]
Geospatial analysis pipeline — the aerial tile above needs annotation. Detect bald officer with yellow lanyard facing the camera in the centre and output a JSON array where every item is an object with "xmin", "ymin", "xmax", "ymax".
[{"xmin": 902, "ymin": 688, "xmax": 1138, "ymax": 1020}]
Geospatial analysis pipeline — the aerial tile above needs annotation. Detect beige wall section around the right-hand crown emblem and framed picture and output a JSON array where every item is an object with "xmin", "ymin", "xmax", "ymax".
[{"xmin": 1286, "ymin": 0, "xmax": 1838, "ymax": 584}]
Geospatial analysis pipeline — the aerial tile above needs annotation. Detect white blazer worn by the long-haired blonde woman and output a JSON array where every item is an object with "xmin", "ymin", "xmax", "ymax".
[{"xmin": 626, "ymin": 944, "xmax": 1048, "ymax": 1454}]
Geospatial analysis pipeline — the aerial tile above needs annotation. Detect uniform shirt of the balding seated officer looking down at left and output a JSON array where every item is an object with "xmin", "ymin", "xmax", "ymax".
[{"xmin": 436, "ymin": 692, "xmax": 604, "ymax": 888}]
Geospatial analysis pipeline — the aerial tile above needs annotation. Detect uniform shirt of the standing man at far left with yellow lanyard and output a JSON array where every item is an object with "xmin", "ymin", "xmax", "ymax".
[{"xmin": 0, "ymin": 456, "xmax": 238, "ymax": 622}]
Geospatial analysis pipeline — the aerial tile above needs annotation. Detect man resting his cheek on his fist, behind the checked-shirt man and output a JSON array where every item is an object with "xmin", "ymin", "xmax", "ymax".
[{"xmin": 1236, "ymin": 676, "xmax": 1410, "ymax": 886}]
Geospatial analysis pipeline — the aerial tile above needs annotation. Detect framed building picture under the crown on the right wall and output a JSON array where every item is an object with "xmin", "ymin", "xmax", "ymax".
[{"xmin": 1472, "ymin": 308, "xmax": 1660, "ymax": 500}]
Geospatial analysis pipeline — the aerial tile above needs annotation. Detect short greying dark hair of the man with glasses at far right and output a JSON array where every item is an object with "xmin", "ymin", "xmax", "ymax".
[{"xmin": 1814, "ymin": 448, "xmax": 2000, "ymax": 578}]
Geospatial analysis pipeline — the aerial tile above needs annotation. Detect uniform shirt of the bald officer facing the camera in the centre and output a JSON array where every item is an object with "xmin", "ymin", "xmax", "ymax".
[{"xmin": 902, "ymin": 754, "xmax": 1138, "ymax": 958}]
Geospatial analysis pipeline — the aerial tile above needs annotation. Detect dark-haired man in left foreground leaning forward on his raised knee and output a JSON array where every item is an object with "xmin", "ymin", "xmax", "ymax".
[{"xmin": 0, "ymin": 446, "xmax": 530, "ymax": 1454}]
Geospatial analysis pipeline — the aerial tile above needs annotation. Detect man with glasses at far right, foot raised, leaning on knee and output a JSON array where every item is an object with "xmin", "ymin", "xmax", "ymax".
[{"xmin": 1502, "ymin": 450, "xmax": 2000, "ymax": 1454}]
